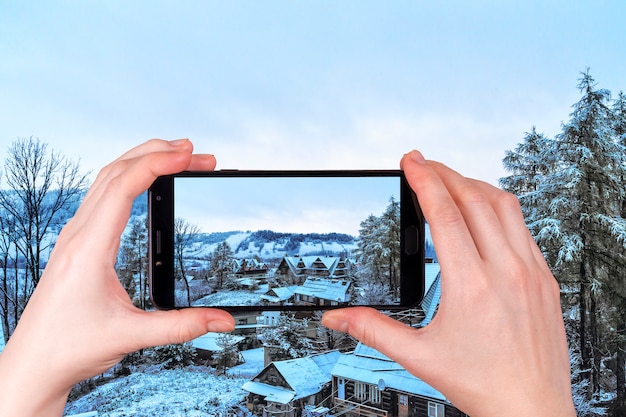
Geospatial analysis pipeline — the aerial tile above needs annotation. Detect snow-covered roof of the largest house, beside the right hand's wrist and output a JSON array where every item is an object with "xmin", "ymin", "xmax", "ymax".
[{"xmin": 332, "ymin": 344, "xmax": 447, "ymax": 401}]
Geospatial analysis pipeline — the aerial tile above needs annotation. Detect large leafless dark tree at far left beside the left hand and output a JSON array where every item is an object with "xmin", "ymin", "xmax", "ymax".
[{"xmin": 0, "ymin": 137, "xmax": 86, "ymax": 334}]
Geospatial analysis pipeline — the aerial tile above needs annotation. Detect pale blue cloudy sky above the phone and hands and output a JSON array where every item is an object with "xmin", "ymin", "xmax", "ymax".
[{"xmin": 0, "ymin": 0, "xmax": 626, "ymax": 184}]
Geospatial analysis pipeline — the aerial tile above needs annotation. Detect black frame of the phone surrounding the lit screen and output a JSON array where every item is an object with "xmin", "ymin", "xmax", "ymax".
[{"xmin": 148, "ymin": 170, "xmax": 425, "ymax": 312}]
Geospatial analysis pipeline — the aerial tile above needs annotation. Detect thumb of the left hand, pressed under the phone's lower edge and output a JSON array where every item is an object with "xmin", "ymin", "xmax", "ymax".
[{"xmin": 127, "ymin": 308, "xmax": 235, "ymax": 351}]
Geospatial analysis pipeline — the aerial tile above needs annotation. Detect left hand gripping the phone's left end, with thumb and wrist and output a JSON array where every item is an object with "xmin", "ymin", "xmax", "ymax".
[{"xmin": 0, "ymin": 140, "xmax": 234, "ymax": 416}]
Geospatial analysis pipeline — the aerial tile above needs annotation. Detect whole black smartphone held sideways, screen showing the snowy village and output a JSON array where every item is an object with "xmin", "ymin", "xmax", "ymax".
[{"xmin": 148, "ymin": 170, "xmax": 425, "ymax": 311}]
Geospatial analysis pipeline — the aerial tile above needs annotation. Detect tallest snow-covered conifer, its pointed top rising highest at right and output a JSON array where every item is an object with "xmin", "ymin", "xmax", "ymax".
[{"xmin": 536, "ymin": 70, "xmax": 624, "ymax": 396}]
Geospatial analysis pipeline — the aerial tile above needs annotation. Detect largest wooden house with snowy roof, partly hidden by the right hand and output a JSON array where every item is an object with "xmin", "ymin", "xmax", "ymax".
[{"xmin": 331, "ymin": 344, "xmax": 467, "ymax": 417}]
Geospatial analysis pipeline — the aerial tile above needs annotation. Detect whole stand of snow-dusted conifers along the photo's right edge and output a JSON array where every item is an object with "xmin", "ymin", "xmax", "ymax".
[{"xmin": 501, "ymin": 70, "xmax": 626, "ymax": 416}]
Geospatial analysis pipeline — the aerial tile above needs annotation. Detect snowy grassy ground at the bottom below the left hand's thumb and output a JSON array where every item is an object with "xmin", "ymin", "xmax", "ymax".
[{"xmin": 65, "ymin": 366, "xmax": 248, "ymax": 417}]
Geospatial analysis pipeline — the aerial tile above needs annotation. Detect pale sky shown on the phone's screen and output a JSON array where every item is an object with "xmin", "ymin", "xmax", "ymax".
[{"xmin": 174, "ymin": 177, "xmax": 400, "ymax": 236}]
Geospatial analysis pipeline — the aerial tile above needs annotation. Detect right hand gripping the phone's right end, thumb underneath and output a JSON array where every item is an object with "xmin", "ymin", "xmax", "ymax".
[{"xmin": 322, "ymin": 151, "xmax": 575, "ymax": 417}]
